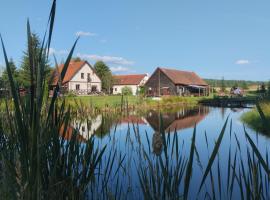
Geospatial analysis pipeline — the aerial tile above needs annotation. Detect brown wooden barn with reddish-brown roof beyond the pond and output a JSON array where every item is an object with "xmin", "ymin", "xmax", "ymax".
[{"xmin": 145, "ymin": 68, "xmax": 209, "ymax": 96}]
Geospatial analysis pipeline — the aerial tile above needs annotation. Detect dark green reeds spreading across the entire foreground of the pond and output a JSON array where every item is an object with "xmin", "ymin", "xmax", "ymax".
[{"xmin": 0, "ymin": 0, "xmax": 270, "ymax": 199}]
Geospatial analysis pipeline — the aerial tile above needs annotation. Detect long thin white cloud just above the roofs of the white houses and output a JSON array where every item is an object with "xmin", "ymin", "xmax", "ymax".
[{"xmin": 77, "ymin": 53, "xmax": 134, "ymax": 65}]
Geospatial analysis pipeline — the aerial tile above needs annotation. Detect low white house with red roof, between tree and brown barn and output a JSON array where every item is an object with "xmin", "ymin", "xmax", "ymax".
[{"xmin": 113, "ymin": 74, "xmax": 148, "ymax": 95}]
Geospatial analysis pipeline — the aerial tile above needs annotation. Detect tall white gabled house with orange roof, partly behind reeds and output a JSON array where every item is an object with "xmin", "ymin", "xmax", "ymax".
[{"xmin": 52, "ymin": 61, "xmax": 101, "ymax": 94}]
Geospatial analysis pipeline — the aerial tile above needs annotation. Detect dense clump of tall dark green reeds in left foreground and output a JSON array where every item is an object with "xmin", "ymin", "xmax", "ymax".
[{"xmin": 0, "ymin": 0, "xmax": 106, "ymax": 200}]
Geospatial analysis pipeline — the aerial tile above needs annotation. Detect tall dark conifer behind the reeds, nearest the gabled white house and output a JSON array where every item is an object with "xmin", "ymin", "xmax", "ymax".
[{"xmin": 19, "ymin": 33, "xmax": 52, "ymax": 88}]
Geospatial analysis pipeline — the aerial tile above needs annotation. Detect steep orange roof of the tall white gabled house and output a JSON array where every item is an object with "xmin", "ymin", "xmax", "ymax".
[{"xmin": 53, "ymin": 61, "xmax": 91, "ymax": 85}]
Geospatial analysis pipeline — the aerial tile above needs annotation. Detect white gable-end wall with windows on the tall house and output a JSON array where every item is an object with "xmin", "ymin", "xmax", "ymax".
[{"xmin": 68, "ymin": 64, "xmax": 101, "ymax": 92}]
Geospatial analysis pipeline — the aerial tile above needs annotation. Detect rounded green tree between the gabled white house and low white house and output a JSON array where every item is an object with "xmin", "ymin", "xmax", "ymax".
[{"xmin": 94, "ymin": 61, "xmax": 113, "ymax": 93}]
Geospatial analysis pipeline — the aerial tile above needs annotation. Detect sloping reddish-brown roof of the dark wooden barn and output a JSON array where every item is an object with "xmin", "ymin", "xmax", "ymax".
[{"xmin": 158, "ymin": 68, "xmax": 208, "ymax": 86}]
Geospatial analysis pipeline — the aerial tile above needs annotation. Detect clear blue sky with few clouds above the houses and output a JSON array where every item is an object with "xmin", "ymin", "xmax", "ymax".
[{"xmin": 0, "ymin": 0, "xmax": 270, "ymax": 80}]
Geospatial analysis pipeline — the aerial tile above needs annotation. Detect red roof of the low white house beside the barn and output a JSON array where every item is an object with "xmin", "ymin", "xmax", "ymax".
[{"xmin": 113, "ymin": 74, "xmax": 147, "ymax": 85}]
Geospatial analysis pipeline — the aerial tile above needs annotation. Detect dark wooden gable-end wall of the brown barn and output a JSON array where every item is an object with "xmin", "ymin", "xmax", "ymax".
[{"xmin": 145, "ymin": 70, "xmax": 177, "ymax": 96}]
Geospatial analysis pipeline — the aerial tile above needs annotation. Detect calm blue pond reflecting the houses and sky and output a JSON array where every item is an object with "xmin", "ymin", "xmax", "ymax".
[{"xmin": 72, "ymin": 106, "xmax": 270, "ymax": 199}]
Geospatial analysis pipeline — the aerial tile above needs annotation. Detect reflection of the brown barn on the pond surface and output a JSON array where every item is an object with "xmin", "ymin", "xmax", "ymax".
[{"xmin": 146, "ymin": 107, "xmax": 209, "ymax": 132}]
